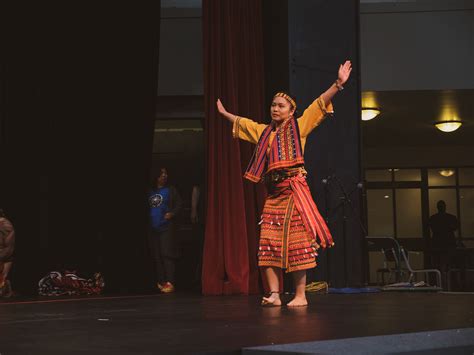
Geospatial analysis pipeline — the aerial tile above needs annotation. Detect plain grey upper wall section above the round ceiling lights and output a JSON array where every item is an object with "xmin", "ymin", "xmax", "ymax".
[{"xmin": 360, "ymin": 1, "xmax": 474, "ymax": 91}]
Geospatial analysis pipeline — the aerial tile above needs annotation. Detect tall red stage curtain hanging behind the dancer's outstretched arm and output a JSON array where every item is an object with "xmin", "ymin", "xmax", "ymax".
[{"xmin": 202, "ymin": 0, "xmax": 266, "ymax": 295}]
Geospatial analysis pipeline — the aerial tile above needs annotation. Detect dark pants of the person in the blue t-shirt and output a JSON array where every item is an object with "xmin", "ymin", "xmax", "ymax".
[{"xmin": 150, "ymin": 228, "xmax": 178, "ymax": 284}]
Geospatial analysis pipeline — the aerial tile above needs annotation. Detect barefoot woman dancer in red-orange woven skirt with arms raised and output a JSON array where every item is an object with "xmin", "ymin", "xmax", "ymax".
[{"xmin": 217, "ymin": 61, "xmax": 352, "ymax": 307}]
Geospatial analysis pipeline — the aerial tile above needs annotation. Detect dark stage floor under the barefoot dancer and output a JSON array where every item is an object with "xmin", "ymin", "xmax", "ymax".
[{"xmin": 0, "ymin": 293, "xmax": 474, "ymax": 355}]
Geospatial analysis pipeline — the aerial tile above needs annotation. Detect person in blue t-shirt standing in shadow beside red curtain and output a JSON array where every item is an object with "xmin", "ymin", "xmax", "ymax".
[{"xmin": 148, "ymin": 168, "xmax": 181, "ymax": 293}]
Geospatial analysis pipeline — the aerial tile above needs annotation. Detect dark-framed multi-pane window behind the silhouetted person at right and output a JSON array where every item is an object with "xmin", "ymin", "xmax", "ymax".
[{"xmin": 365, "ymin": 167, "xmax": 474, "ymax": 242}]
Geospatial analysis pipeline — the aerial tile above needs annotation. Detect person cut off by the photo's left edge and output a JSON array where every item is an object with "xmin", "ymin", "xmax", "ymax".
[{"xmin": 0, "ymin": 209, "xmax": 15, "ymax": 297}]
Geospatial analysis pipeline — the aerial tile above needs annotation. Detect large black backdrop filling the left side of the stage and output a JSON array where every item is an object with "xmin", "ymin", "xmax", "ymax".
[{"xmin": 0, "ymin": 1, "xmax": 160, "ymax": 293}]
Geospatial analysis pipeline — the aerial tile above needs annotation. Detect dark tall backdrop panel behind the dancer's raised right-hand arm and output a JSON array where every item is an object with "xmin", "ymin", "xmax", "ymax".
[{"xmin": 263, "ymin": 0, "xmax": 365, "ymax": 287}]
